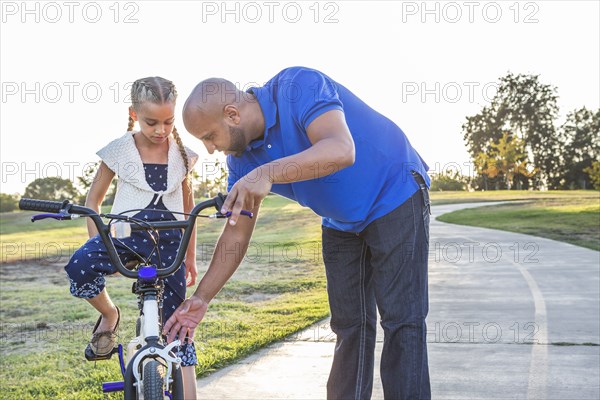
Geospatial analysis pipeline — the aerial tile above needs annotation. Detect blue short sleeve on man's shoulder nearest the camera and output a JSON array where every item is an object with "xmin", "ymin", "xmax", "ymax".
[{"xmin": 282, "ymin": 68, "xmax": 344, "ymax": 129}]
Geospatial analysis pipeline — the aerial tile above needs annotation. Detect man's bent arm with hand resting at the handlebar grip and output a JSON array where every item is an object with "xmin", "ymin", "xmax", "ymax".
[{"xmin": 221, "ymin": 110, "xmax": 354, "ymax": 225}]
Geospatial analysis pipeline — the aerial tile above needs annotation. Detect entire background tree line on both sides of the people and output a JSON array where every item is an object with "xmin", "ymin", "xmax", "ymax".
[{"xmin": 0, "ymin": 73, "xmax": 600, "ymax": 212}]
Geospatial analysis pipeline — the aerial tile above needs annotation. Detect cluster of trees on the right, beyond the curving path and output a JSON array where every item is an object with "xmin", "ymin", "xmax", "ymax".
[{"xmin": 462, "ymin": 73, "xmax": 600, "ymax": 190}]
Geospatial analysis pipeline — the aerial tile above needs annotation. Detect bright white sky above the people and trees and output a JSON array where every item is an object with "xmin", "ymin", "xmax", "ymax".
[{"xmin": 0, "ymin": 1, "xmax": 600, "ymax": 193}]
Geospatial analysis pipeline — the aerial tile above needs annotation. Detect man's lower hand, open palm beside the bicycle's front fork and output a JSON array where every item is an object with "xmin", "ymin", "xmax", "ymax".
[{"xmin": 163, "ymin": 295, "xmax": 208, "ymax": 343}]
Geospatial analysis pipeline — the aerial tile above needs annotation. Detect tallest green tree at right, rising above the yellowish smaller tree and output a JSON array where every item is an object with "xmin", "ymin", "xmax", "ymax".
[{"xmin": 462, "ymin": 73, "xmax": 561, "ymax": 188}]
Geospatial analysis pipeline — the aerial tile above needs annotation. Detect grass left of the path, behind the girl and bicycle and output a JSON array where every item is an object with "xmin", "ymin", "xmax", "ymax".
[{"xmin": 0, "ymin": 196, "xmax": 329, "ymax": 399}]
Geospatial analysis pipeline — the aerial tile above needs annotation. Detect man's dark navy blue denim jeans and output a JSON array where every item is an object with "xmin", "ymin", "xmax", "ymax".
[{"xmin": 323, "ymin": 183, "xmax": 431, "ymax": 400}]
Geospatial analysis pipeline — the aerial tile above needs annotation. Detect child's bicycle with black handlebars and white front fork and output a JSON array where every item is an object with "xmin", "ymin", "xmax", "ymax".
[{"xmin": 19, "ymin": 194, "xmax": 252, "ymax": 399}]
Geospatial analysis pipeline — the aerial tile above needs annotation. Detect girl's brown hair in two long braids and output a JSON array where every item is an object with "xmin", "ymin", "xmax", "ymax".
[{"xmin": 127, "ymin": 76, "xmax": 190, "ymax": 174}]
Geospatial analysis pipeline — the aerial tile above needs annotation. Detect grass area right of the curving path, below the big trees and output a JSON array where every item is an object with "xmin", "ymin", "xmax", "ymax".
[{"xmin": 433, "ymin": 191, "xmax": 600, "ymax": 250}]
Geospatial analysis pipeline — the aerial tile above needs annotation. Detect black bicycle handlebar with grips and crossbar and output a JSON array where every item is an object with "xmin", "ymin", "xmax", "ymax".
[{"xmin": 19, "ymin": 193, "xmax": 225, "ymax": 279}]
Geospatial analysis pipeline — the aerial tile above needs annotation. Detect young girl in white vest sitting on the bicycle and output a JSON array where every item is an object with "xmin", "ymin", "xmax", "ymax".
[{"xmin": 65, "ymin": 77, "xmax": 198, "ymax": 399}]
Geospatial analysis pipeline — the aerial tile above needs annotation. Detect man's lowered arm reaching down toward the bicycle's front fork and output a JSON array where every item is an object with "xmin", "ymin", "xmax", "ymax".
[{"xmin": 163, "ymin": 206, "xmax": 259, "ymax": 342}]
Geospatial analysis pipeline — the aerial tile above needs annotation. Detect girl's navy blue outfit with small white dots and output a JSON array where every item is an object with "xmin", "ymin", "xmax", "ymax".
[{"xmin": 65, "ymin": 164, "xmax": 198, "ymax": 367}]
